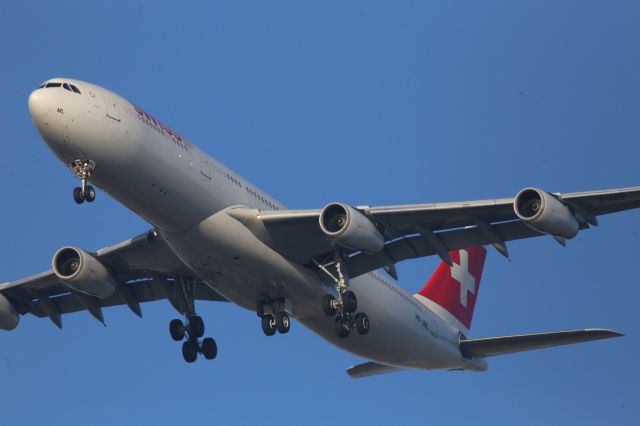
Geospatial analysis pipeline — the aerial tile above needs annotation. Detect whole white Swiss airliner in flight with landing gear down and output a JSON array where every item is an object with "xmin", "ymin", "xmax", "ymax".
[{"xmin": 0, "ymin": 78, "xmax": 640, "ymax": 378}]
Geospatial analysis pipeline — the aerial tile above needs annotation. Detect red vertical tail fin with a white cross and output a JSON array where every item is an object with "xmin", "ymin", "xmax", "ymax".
[{"xmin": 415, "ymin": 247, "xmax": 487, "ymax": 336}]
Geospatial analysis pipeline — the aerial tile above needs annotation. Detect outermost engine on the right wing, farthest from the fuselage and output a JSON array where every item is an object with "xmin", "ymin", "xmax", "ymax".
[{"xmin": 513, "ymin": 188, "xmax": 580, "ymax": 239}]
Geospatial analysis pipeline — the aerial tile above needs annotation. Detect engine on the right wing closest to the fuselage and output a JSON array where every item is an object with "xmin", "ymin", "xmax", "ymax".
[{"xmin": 320, "ymin": 203, "xmax": 384, "ymax": 255}]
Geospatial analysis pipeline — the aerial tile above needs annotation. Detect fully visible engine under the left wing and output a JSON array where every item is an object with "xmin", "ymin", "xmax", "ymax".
[{"xmin": 52, "ymin": 247, "xmax": 116, "ymax": 299}]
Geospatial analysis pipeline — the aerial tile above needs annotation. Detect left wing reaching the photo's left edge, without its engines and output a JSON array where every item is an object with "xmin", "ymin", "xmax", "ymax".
[{"xmin": 0, "ymin": 231, "xmax": 226, "ymax": 328}]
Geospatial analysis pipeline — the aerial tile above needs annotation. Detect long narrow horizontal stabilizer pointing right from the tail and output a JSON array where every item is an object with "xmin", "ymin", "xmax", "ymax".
[{"xmin": 460, "ymin": 328, "xmax": 623, "ymax": 358}]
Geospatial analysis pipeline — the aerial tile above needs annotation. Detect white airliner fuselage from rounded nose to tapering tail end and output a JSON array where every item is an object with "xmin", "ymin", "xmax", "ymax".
[{"xmin": 29, "ymin": 79, "xmax": 484, "ymax": 370}]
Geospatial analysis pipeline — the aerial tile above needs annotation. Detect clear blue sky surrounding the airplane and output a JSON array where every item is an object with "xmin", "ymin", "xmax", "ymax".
[{"xmin": 0, "ymin": 1, "xmax": 640, "ymax": 425}]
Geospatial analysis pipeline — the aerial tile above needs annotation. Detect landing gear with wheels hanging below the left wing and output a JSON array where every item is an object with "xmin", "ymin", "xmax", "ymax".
[{"xmin": 169, "ymin": 279, "xmax": 218, "ymax": 363}]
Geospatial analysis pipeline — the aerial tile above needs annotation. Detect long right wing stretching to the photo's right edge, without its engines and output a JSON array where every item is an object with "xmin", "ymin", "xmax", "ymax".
[{"xmin": 230, "ymin": 187, "xmax": 640, "ymax": 277}]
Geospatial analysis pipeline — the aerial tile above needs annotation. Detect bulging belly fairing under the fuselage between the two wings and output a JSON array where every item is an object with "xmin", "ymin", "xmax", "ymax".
[{"xmin": 162, "ymin": 210, "xmax": 325, "ymax": 317}]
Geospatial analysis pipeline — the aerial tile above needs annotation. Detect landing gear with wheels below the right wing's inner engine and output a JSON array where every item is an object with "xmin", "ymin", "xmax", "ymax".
[{"xmin": 318, "ymin": 253, "xmax": 370, "ymax": 338}]
